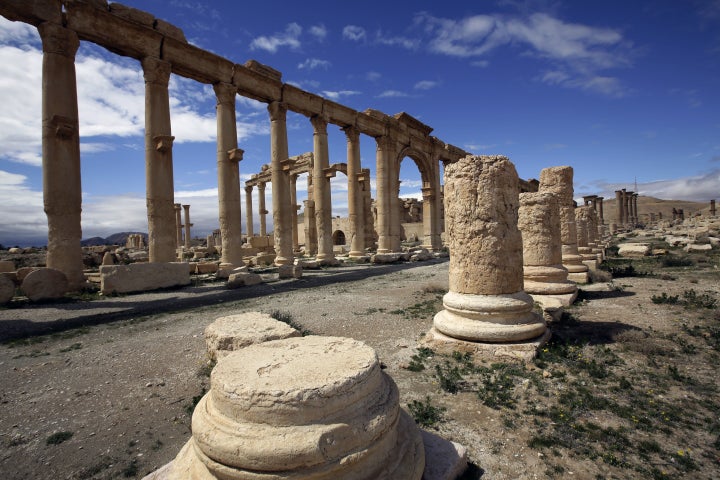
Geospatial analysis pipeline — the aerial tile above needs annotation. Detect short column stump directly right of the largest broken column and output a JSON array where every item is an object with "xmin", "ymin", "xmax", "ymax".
[{"xmin": 518, "ymin": 192, "xmax": 578, "ymax": 307}]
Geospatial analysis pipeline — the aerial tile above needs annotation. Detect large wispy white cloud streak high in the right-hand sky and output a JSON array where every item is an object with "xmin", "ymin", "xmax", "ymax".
[{"xmin": 415, "ymin": 12, "xmax": 631, "ymax": 97}]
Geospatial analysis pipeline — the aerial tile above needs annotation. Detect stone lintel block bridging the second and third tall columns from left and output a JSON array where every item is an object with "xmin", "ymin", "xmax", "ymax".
[{"xmin": 163, "ymin": 38, "xmax": 235, "ymax": 84}]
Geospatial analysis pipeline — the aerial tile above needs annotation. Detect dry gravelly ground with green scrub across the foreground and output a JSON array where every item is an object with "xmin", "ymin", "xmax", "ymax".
[{"xmin": 0, "ymin": 246, "xmax": 720, "ymax": 480}]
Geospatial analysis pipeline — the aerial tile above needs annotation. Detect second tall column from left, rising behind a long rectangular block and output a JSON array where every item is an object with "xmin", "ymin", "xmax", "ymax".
[{"xmin": 141, "ymin": 57, "xmax": 176, "ymax": 262}]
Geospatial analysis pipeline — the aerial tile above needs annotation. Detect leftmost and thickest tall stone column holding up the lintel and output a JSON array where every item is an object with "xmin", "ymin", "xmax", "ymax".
[{"xmin": 38, "ymin": 23, "xmax": 84, "ymax": 290}]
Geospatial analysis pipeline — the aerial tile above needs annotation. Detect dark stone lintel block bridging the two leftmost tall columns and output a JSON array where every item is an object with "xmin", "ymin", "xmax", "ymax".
[{"xmin": 64, "ymin": 0, "xmax": 163, "ymax": 59}]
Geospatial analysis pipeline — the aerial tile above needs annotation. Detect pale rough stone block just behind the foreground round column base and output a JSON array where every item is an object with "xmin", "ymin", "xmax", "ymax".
[{"xmin": 205, "ymin": 312, "xmax": 301, "ymax": 360}]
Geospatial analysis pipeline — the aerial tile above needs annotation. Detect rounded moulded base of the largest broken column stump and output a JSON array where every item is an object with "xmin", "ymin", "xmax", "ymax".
[{"xmin": 433, "ymin": 291, "xmax": 547, "ymax": 343}]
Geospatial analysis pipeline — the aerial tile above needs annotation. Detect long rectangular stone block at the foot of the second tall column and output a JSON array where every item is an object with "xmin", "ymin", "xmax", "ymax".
[{"xmin": 100, "ymin": 262, "xmax": 190, "ymax": 295}]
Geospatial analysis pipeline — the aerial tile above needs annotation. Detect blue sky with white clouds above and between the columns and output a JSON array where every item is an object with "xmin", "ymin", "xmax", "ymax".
[{"xmin": 0, "ymin": 0, "xmax": 720, "ymax": 246}]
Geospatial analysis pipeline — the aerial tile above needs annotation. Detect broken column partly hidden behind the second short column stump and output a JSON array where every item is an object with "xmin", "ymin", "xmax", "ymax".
[{"xmin": 538, "ymin": 166, "xmax": 588, "ymax": 283}]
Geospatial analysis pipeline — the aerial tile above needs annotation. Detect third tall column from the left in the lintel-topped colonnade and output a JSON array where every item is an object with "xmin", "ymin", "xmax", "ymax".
[{"xmin": 213, "ymin": 83, "xmax": 245, "ymax": 269}]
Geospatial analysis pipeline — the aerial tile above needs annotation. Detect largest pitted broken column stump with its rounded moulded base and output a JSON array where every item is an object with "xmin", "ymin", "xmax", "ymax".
[{"xmin": 430, "ymin": 155, "xmax": 547, "ymax": 351}]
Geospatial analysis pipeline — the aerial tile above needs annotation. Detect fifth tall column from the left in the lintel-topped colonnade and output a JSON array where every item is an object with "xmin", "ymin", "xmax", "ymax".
[{"xmin": 310, "ymin": 115, "xmax": 335, "ymax": 263}]
